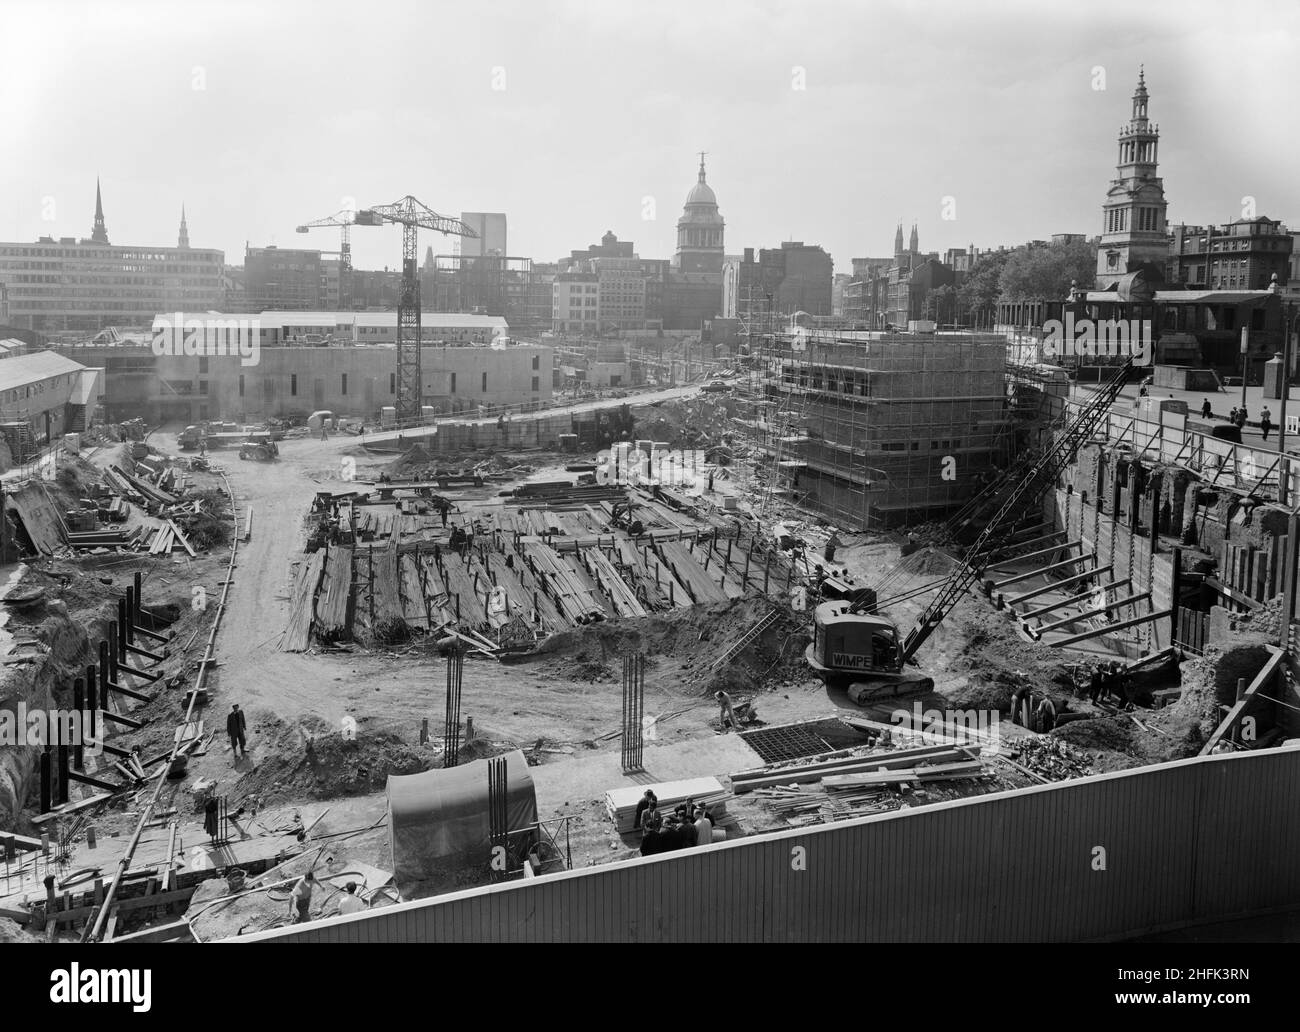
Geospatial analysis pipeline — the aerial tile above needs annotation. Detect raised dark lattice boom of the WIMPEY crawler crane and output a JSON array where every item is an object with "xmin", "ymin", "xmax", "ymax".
[{"xmin": 902, "ymin": 359, "xmax": 1132, "ymax": 659}]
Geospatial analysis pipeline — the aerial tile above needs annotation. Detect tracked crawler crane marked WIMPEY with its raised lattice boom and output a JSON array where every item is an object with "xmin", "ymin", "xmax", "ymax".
[{"xmin": 803, "ymin": 360, "xmax": 1134, "ymax": 706}]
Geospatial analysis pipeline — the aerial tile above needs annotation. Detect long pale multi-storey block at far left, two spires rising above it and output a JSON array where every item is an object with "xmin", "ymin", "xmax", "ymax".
[{"xmin": 0, "ymin": 183, "xmax": 224, "ymax": 334}]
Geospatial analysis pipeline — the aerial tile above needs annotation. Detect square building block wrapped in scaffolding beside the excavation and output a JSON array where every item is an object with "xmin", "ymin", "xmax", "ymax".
[{"xmin": 740, "ymin": 327, "xmax": 1017, "ymax": 530}]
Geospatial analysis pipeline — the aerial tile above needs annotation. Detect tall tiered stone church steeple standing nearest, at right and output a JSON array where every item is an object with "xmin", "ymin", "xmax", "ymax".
[{"xmin": 1097, "ymin": 69, "xmax": 1169, "ymax": 290}]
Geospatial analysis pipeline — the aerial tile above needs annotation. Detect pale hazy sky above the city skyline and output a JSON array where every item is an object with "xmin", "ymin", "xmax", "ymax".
[{"xmin": 0, "ymin": 0, "xmax": 1300, "ymax": 272}]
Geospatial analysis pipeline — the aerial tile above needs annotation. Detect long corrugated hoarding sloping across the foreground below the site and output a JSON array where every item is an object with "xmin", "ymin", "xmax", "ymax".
[{"xmin": 243, "ymin": 749, "xmax": 1300, "ymax": 942}]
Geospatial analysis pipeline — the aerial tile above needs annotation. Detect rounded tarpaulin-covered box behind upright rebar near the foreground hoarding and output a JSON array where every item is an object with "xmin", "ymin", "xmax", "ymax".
[{"xmin": 387, "ymin": 750, "xmax": 537, "ymax": 885}]
